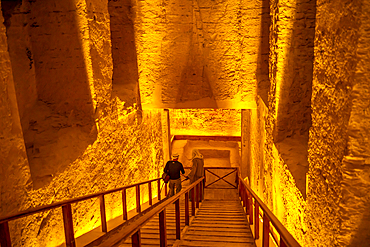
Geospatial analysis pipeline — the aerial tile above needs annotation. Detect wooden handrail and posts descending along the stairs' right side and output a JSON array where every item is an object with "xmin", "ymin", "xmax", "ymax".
[{"xmin": 239, "ymin": 176, "xmax": 301, "ymax": 247}]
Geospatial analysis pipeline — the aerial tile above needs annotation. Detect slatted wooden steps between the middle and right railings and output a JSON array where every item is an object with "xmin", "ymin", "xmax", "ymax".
[{"xmin": 178, "ymin": 199, "xmax": 256, "ymax": 247}]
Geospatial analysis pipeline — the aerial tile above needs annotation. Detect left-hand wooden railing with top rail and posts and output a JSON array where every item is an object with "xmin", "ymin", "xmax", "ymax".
[{"xmin": 0, "ymin": 178, "xmax": 167, "ymax": 247}]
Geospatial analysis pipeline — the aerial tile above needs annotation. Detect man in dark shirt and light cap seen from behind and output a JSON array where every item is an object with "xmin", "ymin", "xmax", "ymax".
[{"xmin": 164, "ymin": 153, "xmax": 185, "ymax": 197}]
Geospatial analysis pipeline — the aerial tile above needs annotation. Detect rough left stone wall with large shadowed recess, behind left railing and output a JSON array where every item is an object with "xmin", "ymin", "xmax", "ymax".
[{"xmin": 0, "ymin": 0, "xmax": 163, "ymax": 246}]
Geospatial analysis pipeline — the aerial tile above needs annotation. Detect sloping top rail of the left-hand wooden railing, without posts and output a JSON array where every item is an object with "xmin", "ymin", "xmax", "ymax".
[{"xmin": 0, "ymin": 178, "xmax": 161, "ymax": 224}]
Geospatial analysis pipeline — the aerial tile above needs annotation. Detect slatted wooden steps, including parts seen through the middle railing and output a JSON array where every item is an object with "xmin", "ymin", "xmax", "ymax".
[{"xmin": 115, "ymin": 199, "xmax": 256, "ymax": 247}]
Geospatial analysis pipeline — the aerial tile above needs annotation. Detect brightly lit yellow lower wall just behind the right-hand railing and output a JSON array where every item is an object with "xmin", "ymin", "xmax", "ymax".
[{"xmin": 250, "ymin": 98, "xmax": 310, "ymax": 246}]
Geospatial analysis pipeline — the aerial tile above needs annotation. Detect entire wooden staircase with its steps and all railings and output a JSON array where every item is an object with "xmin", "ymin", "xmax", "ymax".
[{"xmin": 0, "ymin": 167, "xmax": 301, "ymax": 247}]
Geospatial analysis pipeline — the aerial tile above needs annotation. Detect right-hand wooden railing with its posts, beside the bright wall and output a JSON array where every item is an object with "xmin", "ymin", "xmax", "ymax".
[{"xmin": 238, "ymin": 173, "xmax": 301, "ymax": 247}]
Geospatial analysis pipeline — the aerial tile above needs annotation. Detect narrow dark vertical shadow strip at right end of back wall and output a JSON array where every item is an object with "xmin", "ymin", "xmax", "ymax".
[{"xmin": 256, "ymin": 0, "xmax": 271, "ymax": 106}]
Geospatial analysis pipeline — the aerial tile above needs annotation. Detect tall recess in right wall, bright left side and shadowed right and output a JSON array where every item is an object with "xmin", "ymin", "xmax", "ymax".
[{"xmin": 267, "ymin": 0, "xmax": 316, "ymax": 199}]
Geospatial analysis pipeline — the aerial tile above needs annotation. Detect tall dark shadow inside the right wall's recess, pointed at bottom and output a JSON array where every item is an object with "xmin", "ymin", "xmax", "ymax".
[{"xmin": 274, "ymin": 0, "xmax": 316, "ymax": 198}]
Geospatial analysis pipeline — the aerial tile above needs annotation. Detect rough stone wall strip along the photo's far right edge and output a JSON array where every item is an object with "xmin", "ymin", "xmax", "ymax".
[{"xmin": 338, "ymin": 1, "xmax": 370, "ymax": 246}]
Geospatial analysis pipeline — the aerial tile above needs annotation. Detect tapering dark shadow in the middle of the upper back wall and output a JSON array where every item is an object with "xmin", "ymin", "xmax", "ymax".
[{"xmin": 172, "ymin": 0, "xmax": 218, "ymax": 109}]
